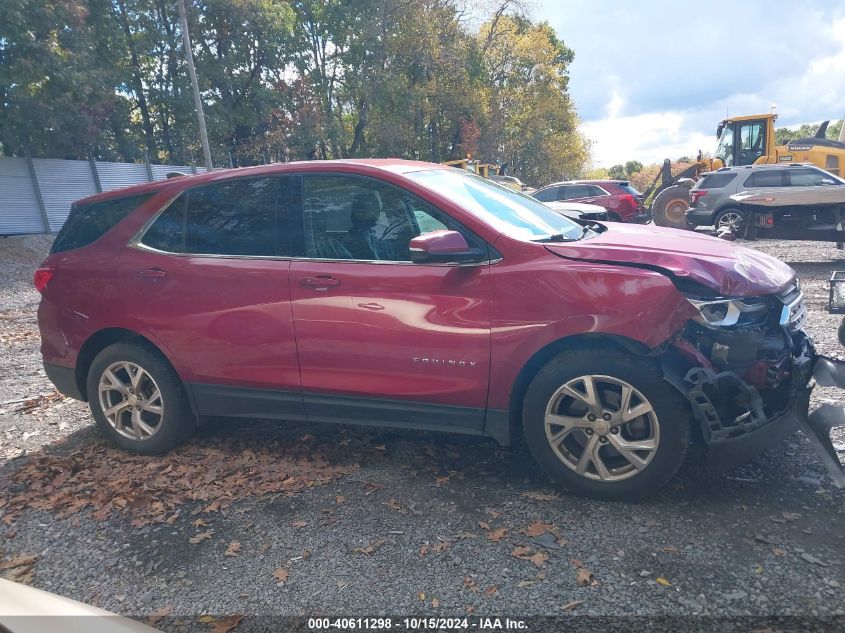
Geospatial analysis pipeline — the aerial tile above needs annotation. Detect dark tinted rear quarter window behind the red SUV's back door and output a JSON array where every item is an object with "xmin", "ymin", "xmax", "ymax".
[{"xmin": 50, "ymin": 192, "xmax": 157, "ymax": 253}]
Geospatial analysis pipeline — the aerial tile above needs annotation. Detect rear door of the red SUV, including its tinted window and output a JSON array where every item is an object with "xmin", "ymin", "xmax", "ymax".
[{"xmin": 120, "ymin": 176, "xmax": 304, "ymax": 419}]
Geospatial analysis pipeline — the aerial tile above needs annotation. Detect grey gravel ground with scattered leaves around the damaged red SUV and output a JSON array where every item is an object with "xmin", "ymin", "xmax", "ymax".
[{"xmin": 0, "ymin": 236, "xmax": 845, "ymax": 631}]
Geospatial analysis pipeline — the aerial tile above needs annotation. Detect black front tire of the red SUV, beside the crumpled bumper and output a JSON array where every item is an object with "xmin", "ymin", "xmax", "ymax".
[{"xmin": 522, "ymin": 349, "xmax": 692, "ymax": 501}]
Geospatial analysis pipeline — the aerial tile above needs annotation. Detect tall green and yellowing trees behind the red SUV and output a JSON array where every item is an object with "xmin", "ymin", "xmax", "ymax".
[{"xmin": 0, "ymin": 0, "xmax": 589, "ymax": 184}]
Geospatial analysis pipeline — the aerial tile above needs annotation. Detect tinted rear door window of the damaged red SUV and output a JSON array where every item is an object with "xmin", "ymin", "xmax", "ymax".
[{"xmin": 141, "ymin": 177, "xmax": 292, "ymax": 257}]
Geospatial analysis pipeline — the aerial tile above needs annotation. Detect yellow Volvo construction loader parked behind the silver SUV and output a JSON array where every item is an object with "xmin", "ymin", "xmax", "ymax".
[{"xmin": 643, "ymin": 114, "xmax": 845, "ymax": 228}]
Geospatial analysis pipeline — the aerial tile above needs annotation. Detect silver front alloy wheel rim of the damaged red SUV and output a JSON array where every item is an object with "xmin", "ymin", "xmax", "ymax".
[{"xmin": 545, "ymin": 375, "xmax": 660, "ymax": 482}]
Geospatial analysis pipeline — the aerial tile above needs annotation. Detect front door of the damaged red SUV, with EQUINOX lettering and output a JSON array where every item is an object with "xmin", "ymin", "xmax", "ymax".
[{"xmin": 290, "ymin": 173, "xmax": 490, "ymax": 433}]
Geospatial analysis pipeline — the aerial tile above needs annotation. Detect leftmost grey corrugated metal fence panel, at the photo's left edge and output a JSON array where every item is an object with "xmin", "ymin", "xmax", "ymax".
[{"xmin": 0, "ymin": 158, "xmax": 44, "ymax": 235}]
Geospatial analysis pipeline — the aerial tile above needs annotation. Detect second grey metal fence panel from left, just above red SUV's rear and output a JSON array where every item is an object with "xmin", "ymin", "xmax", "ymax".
[{"xmin": 32, "ymin": 158, "xmax": 97, "ymax": 232}]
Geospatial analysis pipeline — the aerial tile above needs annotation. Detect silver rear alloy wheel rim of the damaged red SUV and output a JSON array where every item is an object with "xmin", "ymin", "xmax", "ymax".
[{"xmin": 99, "ymin": 361, "xmax": 164, "ymax": 440}]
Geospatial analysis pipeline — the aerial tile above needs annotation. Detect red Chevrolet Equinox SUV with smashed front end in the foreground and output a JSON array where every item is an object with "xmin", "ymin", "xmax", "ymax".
[{"xmin": 35, "ymin": 160, "xmax": 813, "ymax": 499}]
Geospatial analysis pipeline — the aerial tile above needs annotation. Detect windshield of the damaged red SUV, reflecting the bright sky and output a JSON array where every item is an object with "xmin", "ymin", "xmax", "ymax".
[{"xmin": 406, "ymin": 169, "xmax": 584, "ymax": 240}]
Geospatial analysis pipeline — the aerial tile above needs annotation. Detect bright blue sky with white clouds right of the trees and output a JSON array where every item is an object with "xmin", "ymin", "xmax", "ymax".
[{"xmin": 534, "ymin": 0, "xmax": 845, "ymax": 167}]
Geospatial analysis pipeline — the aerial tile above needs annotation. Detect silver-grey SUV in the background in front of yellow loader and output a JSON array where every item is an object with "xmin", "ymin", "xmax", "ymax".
[{"xmin": 686, "ymin": 164, "xmax": 845, "ymax": 237}]
